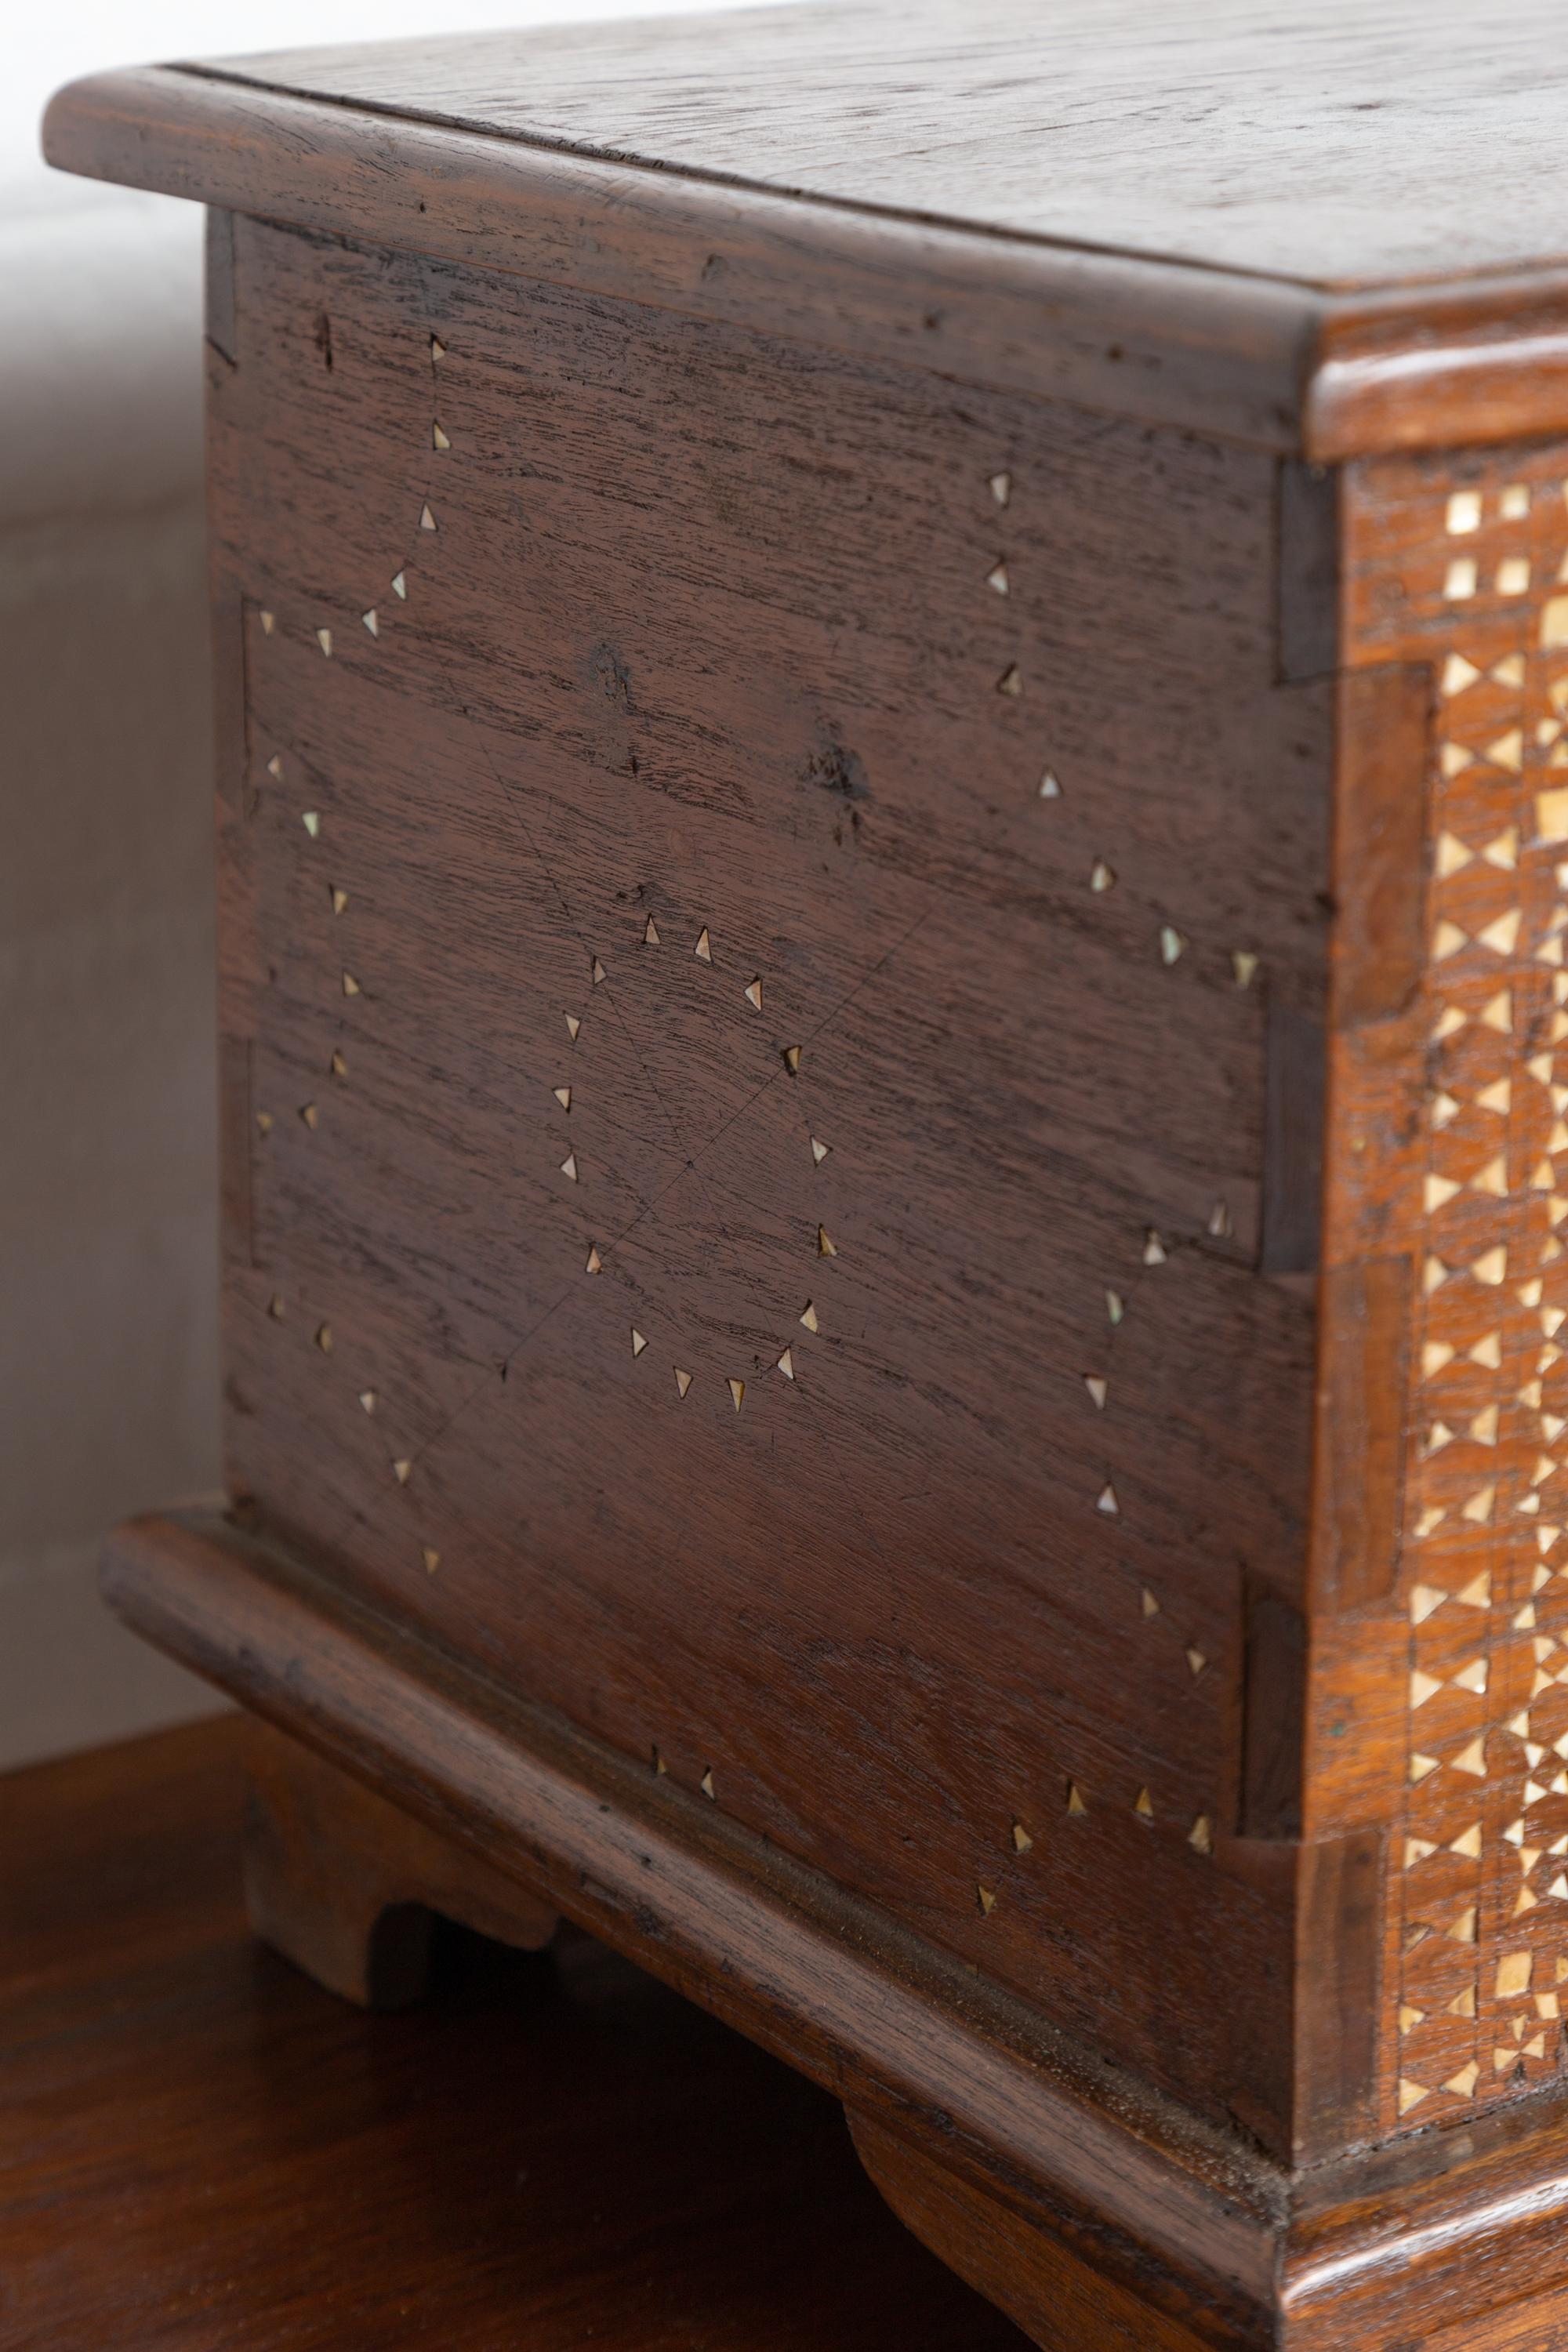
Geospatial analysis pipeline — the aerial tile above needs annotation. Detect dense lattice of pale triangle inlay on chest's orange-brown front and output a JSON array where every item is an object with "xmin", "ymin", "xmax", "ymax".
[{"xmin": 1349, "ymin": 449, "xmax": 1568, "ymax": 2126}]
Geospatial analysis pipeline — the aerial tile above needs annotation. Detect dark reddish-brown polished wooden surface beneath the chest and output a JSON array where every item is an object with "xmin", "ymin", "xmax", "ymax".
[{"xmin": 0, "ymin": 1719, "xmax": 1022, "ymax": 2352}]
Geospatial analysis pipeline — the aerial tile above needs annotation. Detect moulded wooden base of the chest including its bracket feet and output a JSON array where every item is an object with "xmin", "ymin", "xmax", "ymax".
[{"xmin": 103, "ymin": 1515, "xmax": 1568, "ymax": 2352}]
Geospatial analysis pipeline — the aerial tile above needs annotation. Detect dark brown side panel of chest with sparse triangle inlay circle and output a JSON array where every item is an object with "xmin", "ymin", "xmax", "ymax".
[{"xmin": 214, "ymin": 223, "xmax": 1328, "ymax": 2136}]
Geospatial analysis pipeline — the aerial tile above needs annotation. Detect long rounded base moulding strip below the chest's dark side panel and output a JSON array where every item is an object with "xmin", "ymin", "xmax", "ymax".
[{"xmin": 106, "ymin": 1517, "xmax": 1283, "ymax": 2343}]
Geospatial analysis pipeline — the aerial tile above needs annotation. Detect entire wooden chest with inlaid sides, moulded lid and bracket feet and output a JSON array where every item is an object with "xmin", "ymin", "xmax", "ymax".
[{"xmin": 47, "ymin": 0, "xmax": 1568, "ymax": 2352}]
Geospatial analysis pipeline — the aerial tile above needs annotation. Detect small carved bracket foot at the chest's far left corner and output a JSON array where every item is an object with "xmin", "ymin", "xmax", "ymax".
[{"xmin": 245, "ymin": 1722, "xmax": 555, "ymax": 2009}]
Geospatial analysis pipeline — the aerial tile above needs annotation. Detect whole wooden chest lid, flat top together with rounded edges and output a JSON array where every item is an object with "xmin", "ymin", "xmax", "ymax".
[{"xmin": 45, "ymin": 0, "xmax": 1568, "ymax": 459}]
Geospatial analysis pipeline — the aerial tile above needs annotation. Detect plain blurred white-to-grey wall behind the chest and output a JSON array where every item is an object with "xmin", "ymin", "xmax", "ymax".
[{"xmin": 0, "ymin": 0, "xmax": 780, "ymax": 1766}]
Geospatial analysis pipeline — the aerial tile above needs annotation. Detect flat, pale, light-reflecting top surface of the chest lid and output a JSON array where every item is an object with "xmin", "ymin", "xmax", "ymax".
[{"xmin": 192, "ymin": 0, "xmax": 1568, "ymax": 287}]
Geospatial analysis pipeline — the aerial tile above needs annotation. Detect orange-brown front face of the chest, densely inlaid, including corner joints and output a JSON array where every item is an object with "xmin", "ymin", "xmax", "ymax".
[{"xmin": 1307, "ymin": 440, "xmax": 1568, "ymax": 2131}]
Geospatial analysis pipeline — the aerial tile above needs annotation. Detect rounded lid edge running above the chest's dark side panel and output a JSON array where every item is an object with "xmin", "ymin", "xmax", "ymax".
[{"xmin": 45, "ymin": 68, "xmax": 1316, "ymax": 449}]
